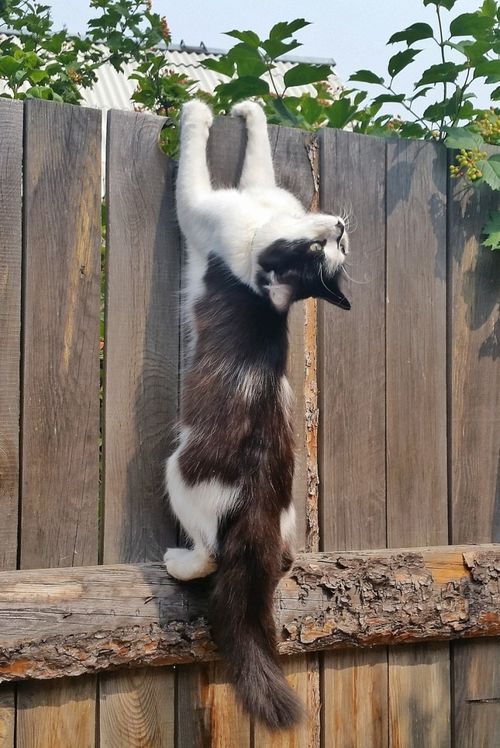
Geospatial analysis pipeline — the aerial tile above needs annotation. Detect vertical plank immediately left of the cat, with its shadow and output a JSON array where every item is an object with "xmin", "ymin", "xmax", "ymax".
[{"xmin": 100, "ymin": 112, "xmax": 180, "ymax": 748}]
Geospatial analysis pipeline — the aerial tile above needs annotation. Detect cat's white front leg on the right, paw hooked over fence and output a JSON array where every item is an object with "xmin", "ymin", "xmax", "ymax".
[{"xmin": 231, "ymin": 101, "xmax": 276, "ymax": 190}]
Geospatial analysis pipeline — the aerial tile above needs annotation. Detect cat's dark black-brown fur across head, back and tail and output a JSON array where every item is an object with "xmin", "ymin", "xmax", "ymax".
[{"xmin": 179, "ymin": 251, "xmax": 348, "ymax": 729}]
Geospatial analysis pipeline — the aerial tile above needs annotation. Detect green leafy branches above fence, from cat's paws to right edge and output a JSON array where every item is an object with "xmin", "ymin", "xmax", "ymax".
[{"xmin": 194, "ymin": 0, "xmax": 500, "ymax": 249}]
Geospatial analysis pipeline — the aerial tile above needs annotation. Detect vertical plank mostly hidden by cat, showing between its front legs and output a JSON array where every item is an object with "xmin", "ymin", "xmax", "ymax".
[{"xmin": 176, "ymin": 118, "xmax": 254, "ymax": 748}]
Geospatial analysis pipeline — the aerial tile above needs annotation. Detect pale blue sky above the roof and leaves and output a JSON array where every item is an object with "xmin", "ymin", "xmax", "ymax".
[{"xmin": 47, "ymin": 0, "xmax": 488, "ymax": 106}]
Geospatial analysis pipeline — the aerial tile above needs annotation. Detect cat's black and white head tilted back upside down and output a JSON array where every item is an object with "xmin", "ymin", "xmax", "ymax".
[{"xmin": 253, "ymin": 213, "xmax": 351, "ymax": 312}]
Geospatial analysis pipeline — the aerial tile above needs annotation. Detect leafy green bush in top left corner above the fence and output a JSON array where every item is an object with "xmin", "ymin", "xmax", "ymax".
[{"xmin": 0, "ymin": 0, "xmax": 170, "ymax": 104}]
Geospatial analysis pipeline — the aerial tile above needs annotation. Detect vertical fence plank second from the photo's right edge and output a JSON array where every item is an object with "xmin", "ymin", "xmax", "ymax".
[{"xmin": 386, "ymin": 141, "xmax": 451, "ymax": 748}]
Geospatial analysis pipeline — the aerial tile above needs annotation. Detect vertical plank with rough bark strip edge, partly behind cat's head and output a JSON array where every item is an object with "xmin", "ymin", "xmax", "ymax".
[{"xmin": 253, "ymin": 127, "xmax": 320, "ymax": 748}]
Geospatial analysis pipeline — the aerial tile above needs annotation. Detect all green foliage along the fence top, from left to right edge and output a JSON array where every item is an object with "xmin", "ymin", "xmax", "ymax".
[{"xmin": 0, "ymin": 0, "xmax": 500, "ymax": 249}]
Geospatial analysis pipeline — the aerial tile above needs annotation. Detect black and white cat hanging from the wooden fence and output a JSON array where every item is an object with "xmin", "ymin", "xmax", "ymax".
[{"xmin": 164, "ymin": 100, "xmax": 350, "ymax": 729}]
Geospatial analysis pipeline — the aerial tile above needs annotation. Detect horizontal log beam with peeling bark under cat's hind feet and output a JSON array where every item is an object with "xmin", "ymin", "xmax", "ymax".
[{"xmin": 0, "ymin": 545, "xmax": 500, "ymax": 681}]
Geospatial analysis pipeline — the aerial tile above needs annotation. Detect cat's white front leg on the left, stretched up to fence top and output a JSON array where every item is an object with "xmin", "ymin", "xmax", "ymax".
[{"xmin": 176, "ymin": 99, "xmax": 213, "ymax": 228}]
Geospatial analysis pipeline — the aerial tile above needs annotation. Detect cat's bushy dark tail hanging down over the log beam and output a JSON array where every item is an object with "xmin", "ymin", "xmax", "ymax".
[{"xmin": 211, "ymin": 513, "xmax": 302, "ymax": 729}]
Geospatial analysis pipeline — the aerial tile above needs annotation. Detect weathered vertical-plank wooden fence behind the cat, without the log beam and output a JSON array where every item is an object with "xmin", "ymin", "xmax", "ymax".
[{"xmin": 0, "ymin": 100, "xmax": 500, "ymax": 748}]
